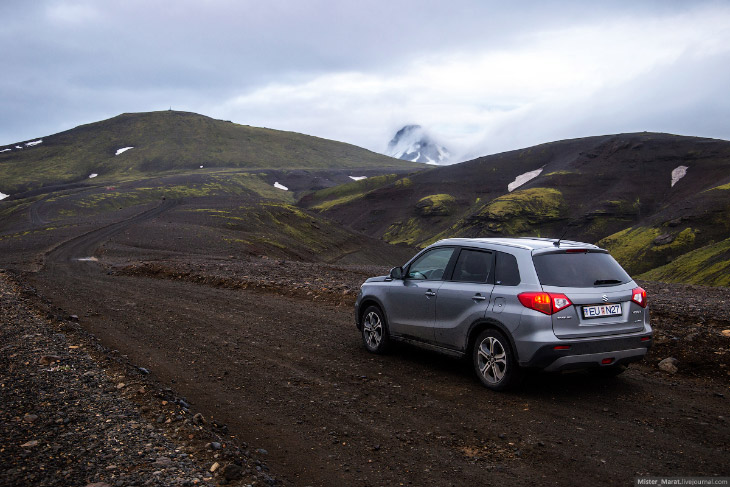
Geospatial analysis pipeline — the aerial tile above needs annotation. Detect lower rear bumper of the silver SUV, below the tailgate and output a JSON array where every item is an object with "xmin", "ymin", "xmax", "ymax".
[{"xmin": 520, "ymin": 333, "xmax": 653, "ymax": 372}]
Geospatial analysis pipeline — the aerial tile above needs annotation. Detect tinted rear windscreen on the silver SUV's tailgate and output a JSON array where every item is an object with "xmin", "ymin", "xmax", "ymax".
[{"xmin": 532, "ymin": 252, "xmax": 631, "ymax": 287}]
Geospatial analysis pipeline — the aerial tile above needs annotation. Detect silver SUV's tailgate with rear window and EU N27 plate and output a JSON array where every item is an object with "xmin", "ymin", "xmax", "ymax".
[{"xmin": 533, "ymin": 249, "xmax": 647, "ymax": 338}]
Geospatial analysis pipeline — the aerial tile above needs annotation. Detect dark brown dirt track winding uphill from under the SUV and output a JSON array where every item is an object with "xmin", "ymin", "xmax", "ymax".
[{"xmin": 19, "ymin": 202, "xmax": 730, "ymax": 485}]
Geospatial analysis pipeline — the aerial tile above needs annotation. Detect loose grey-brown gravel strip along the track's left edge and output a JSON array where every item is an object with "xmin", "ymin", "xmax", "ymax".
[{"xmin": 0, "ymin": 271, "xmax": 276, "ymax": 486}]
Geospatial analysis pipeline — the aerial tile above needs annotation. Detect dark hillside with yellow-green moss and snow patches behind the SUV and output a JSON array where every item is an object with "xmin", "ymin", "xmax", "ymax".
[{"xmin": 300, "ymin": 133, "xmax": 730, "ymax": 284}]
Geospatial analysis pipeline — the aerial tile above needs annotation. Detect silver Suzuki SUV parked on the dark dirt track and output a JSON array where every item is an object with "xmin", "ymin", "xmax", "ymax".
[{"xmin": 355, "ymin": 238, "xmax": 652, "ymax": 390}]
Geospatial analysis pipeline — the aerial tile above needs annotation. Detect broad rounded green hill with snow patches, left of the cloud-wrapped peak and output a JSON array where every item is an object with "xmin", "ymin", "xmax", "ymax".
[{"xmin": 0, "ymin": 111, "xmax": 422, "ymax": 195}]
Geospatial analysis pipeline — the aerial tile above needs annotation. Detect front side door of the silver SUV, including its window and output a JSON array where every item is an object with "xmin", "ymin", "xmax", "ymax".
[{"xmin": 385, "ymin": 247, "xmax": 455, "ymax": 342}]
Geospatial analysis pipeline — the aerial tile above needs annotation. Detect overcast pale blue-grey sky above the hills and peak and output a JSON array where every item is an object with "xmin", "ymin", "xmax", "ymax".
[{"xmin": 0, "ymin": 0, "xmax": 730, "ymax": 162}]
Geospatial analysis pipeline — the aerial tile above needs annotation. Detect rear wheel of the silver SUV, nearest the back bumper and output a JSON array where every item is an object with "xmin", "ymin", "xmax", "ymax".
[{"xmin": 472, "ymin": 330, "xmax": 523, "ymax": 391}]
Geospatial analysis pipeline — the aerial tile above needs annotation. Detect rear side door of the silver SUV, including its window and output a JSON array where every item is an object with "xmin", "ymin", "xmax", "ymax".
[{"xmin": 435, "ymin": 248, "xmax": 494, "ymax": 349}]
